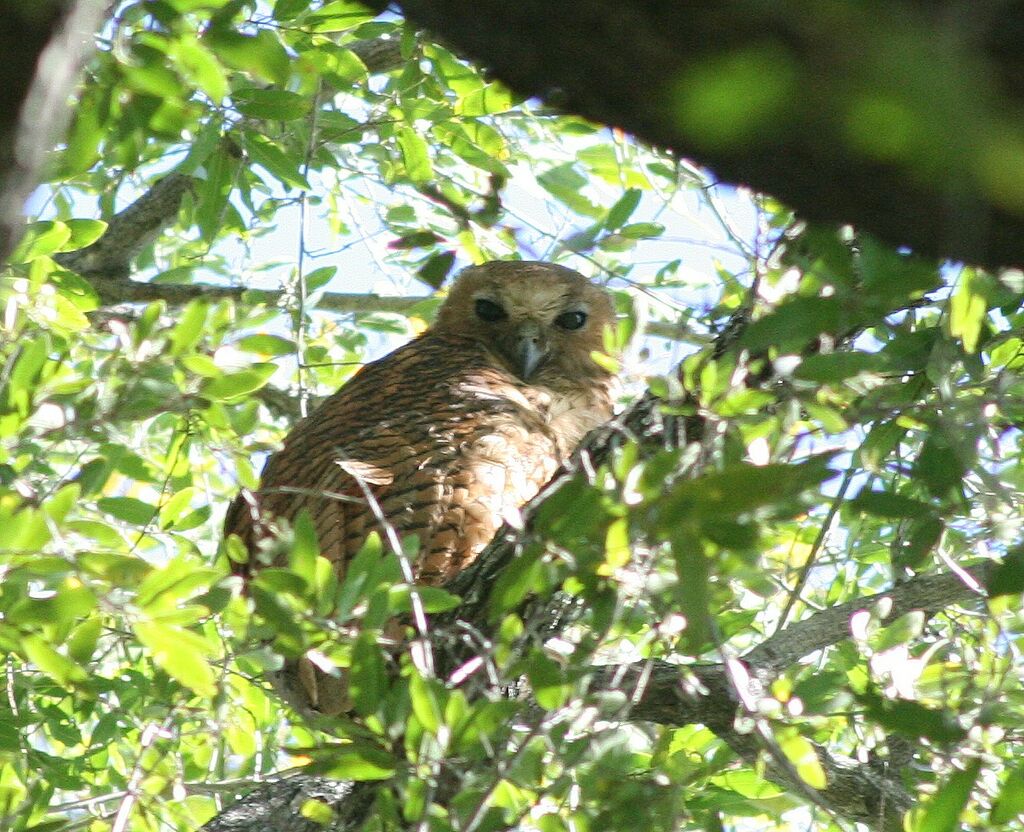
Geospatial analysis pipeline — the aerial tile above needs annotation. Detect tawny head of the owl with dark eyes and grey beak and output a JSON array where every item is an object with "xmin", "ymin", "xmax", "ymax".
[{"xmin": 431, "ymin": 260, "xmax": 614, "ymax": 385}]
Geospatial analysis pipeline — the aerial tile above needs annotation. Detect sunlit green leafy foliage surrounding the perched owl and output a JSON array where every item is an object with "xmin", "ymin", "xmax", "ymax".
[{"xmin": 0, "ymin": 0, "xmax": 1024, "ymax": 832}]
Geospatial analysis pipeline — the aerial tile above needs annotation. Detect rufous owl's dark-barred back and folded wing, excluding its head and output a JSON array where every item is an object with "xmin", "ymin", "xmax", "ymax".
[{"xmin": 225, "ymin": 335, "xmax": 571, "ymax": 713}]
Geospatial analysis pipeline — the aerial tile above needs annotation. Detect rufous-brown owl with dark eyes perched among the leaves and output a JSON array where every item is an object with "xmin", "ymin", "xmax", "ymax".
[{"xmin": 225, "ymin": 261, "xmax": 614, "ymax": 714}]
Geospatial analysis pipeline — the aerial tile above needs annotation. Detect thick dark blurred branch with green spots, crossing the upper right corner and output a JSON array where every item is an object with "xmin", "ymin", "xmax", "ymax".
[{"xmin": 399, "ymin": 0, "xmax": 1024, "ymax": 266}]
